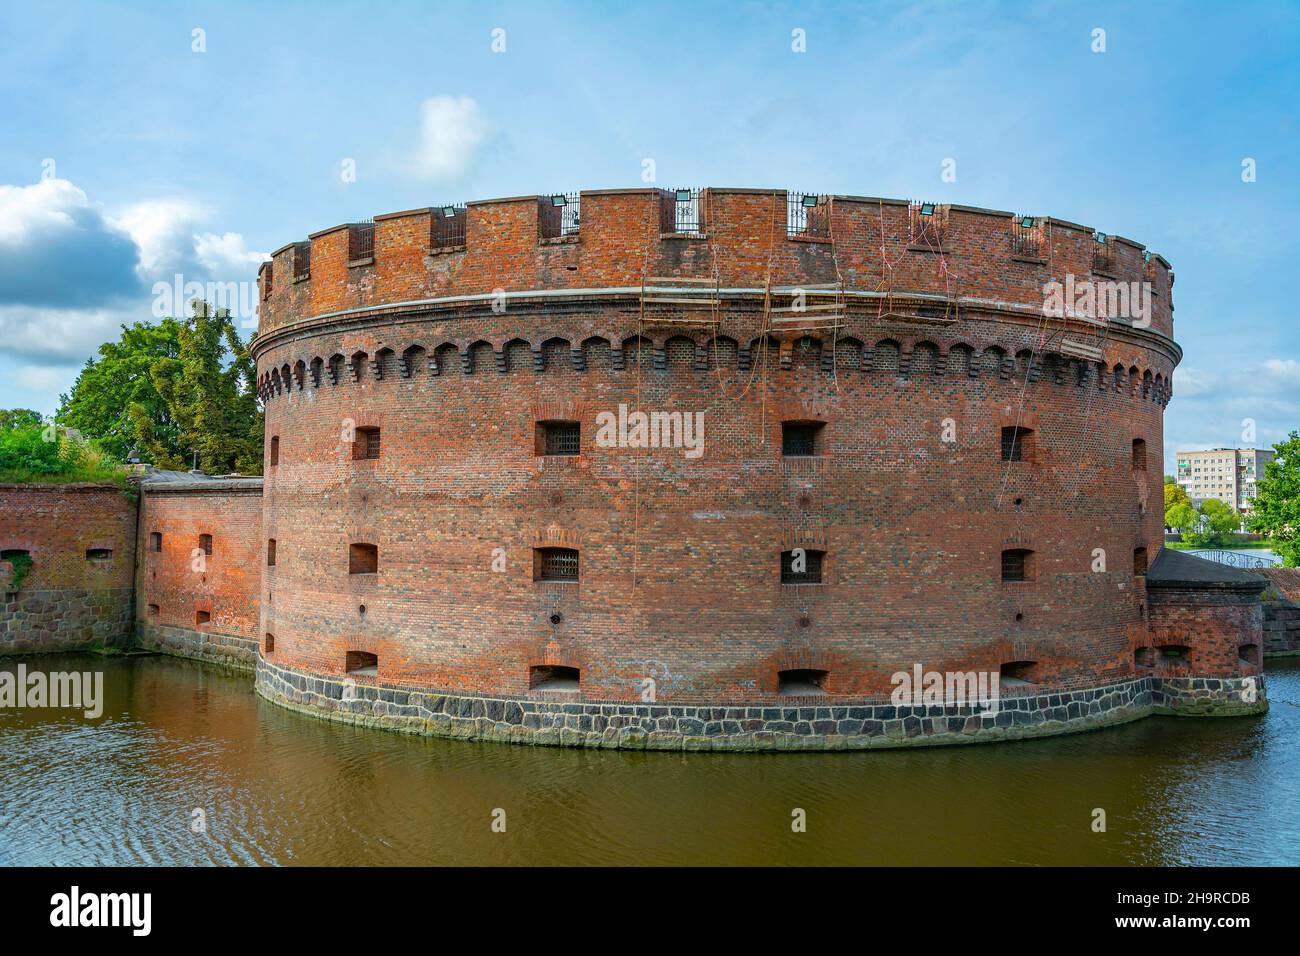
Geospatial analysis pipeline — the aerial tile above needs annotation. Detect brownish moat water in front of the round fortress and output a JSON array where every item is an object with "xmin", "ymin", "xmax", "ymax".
[{"xmin": 0, "ymin": 656, "xmax": 1300, "ymax": 865}]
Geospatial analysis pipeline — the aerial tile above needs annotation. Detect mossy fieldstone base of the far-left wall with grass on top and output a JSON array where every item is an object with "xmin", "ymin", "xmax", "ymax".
[{"xmin": 0, "ymin": 588, "xmax": 133, "ymax": 654}]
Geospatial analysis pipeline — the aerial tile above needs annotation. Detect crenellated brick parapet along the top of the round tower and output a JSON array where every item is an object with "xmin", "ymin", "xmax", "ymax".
[{"xmin": 259, "ymin": 189, "xmax": 1173, "ymax": 338}]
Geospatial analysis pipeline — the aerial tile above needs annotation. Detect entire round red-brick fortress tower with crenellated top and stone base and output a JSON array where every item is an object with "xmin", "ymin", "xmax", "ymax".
[{"xmin": 245, "ymin": 189, "xmax": 1249, "ymax": 748}]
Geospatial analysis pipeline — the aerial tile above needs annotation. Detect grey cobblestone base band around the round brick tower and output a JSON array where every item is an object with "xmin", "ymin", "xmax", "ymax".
[{"xmin": 256, "ymin": 656, "xmax": 1268, "ymax": 750}]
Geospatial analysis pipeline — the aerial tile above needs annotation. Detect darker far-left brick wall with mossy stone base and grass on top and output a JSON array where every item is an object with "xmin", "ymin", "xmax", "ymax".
[{"xmin": 0, "ymin": 484, "xmax": 137, "ymax": 654}]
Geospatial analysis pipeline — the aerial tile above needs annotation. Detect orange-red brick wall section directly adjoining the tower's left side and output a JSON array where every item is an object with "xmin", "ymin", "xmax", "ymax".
[{"xmin": 135, "ymin": 479, "xmax": 263, "ymax": 669}]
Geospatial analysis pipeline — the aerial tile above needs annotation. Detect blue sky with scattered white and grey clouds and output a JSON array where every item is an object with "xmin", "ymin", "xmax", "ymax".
[{"xmin": 0, "ymin": 0, "xmax": 1300, "ymax": 471}]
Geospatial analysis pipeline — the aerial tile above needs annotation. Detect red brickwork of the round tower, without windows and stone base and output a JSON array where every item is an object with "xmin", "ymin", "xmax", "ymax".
[{"xmin": 248, "ymin": 190, "xmax": 1179, "ymax": 700}]
